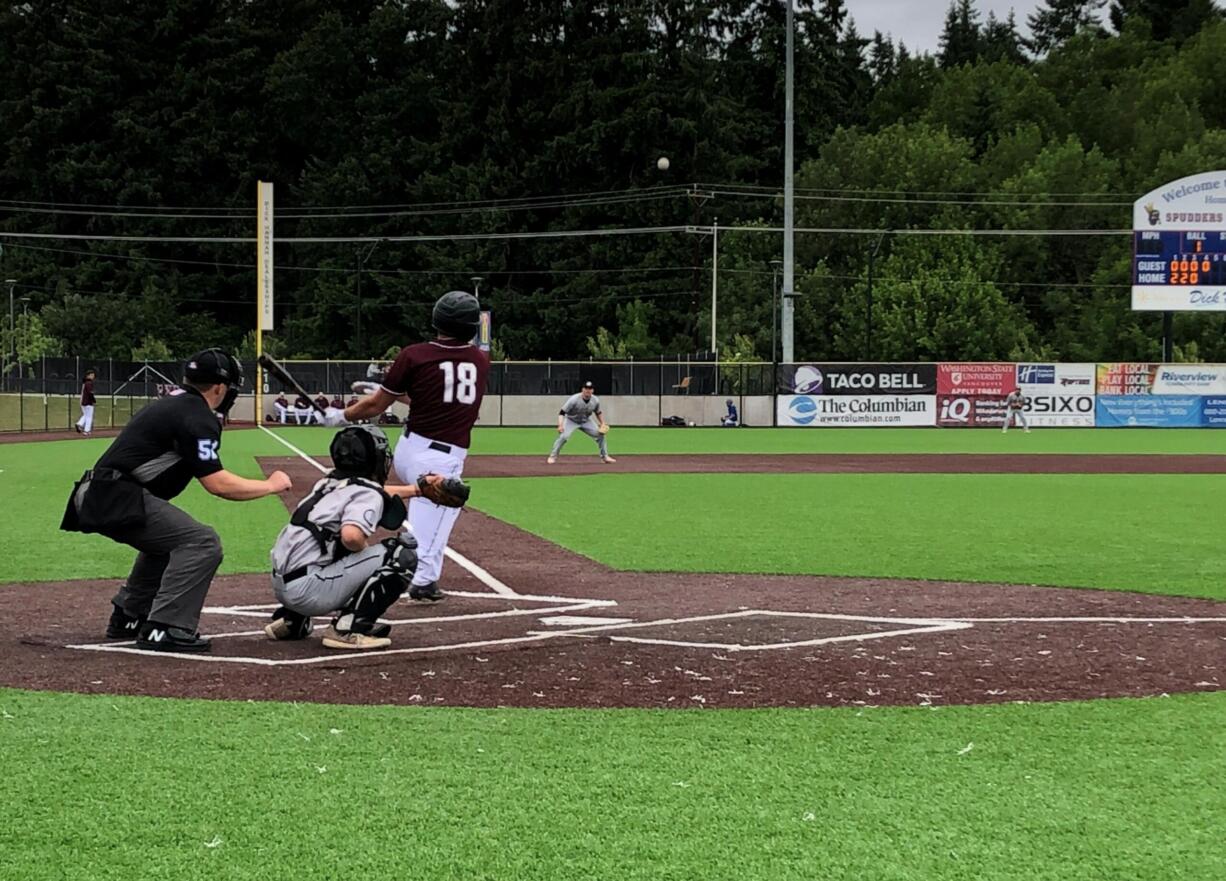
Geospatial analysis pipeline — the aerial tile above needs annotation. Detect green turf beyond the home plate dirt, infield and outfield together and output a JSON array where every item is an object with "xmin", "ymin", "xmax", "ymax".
[{"xmin": 0, "ymin": 429, "xmax": 1226, "ymax": 585}]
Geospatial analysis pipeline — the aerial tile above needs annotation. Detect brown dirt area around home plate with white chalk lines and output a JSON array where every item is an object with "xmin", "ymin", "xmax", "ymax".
[{"xmin": 0, "ymin": 457, "xmax": 1226, "ymax": 707}]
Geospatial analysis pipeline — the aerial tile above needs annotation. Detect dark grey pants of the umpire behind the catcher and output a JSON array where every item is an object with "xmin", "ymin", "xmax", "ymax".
[{"xmin": 108, "ymin": 491, "xmax": 222, "ymax": 631}]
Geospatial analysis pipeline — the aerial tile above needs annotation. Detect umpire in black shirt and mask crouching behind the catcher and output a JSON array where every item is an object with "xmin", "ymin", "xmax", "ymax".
[{"xmin": 60, "ymin": 349, "xmax": 292, "ymax": 652}]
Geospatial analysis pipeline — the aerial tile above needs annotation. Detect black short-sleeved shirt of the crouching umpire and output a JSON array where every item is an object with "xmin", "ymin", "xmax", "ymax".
[{"xmin": 94, "ymin": 388, "xmax": 222, "ymax": 499}]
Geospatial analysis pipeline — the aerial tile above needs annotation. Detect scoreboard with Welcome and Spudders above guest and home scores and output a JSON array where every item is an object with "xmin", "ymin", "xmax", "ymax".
[{"xmin": 1133, "ymin": 172, "xmax": 1226, "ymax": 312}]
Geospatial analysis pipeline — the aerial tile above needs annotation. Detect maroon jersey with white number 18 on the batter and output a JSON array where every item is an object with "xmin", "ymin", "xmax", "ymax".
[{"xmin": 383, "ymin": 339, "xmax": 489, "ymax": 450}]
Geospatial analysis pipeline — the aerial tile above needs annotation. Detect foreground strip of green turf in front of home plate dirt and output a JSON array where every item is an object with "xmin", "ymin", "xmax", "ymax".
[{"xmin": 0, "ymin": 691, "xmax": 1226, "ymax": 881}]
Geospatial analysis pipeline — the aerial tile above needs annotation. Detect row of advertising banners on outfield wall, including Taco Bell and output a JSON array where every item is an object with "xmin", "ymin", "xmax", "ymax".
[{"xmin": 776, "ymin": 361, "xmax": 1226, "ymax": 428}]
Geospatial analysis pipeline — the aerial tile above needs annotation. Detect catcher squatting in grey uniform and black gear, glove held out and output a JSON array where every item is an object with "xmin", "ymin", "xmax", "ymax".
[{"xmin": 264, "ymin": 425, "xmax": 468, "ymax": 651}]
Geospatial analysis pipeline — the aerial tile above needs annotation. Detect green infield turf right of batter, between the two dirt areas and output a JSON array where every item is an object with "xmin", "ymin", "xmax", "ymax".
[{"xmin": 472, "ymin": 473, "xmax": 1226, "ymax": 598}]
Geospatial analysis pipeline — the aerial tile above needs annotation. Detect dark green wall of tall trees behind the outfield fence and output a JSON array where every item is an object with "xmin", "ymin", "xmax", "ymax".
[{"xmin": 0, "ymin": 0, "xmax": 1226, "ymax": 360}]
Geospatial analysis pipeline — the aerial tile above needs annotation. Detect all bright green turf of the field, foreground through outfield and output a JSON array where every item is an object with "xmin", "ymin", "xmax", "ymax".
[{"xmin": 0, "ymin": 429, "xmax": 1226, "ymax": 881}]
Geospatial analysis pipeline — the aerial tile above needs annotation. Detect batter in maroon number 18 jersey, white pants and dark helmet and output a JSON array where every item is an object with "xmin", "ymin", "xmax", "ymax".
[{"xmin": 325, "ymin": 290, "xmax": 489, "ymax": 603}]
